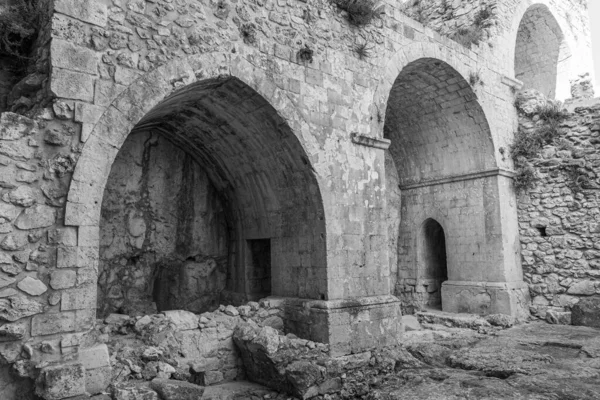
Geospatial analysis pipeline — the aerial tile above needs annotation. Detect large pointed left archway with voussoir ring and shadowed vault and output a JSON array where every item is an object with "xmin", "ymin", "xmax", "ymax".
[{"xmin": 63, "ymin": 52, "xmax": 327, "ymax": 322}]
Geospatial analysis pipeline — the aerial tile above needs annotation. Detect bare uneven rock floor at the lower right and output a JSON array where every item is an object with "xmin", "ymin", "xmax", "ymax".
[{"xmin": 226, "ymin": 317, "xmax": 600, "ymax": 400}]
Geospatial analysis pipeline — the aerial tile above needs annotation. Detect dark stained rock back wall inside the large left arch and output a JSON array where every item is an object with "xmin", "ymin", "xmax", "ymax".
[{"xmin": 98, "ymin": 133, "xmax": 229, "ymax": 316}]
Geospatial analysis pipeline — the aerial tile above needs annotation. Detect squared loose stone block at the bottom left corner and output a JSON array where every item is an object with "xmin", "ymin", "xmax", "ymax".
[{"xmin": 36, "ymin": 364, "xmax": 85, "ymax": 400}]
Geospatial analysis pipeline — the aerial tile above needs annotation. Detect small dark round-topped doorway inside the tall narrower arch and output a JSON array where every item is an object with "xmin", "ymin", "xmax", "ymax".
[{"xmin": 417, "ymin": 218, "xmax": 448, "ymax": 309}]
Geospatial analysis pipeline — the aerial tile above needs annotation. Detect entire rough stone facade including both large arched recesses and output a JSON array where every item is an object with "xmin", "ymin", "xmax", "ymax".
[{"xmin": 0, "ymin": 0, "xmax": 591, "ymax": 400}]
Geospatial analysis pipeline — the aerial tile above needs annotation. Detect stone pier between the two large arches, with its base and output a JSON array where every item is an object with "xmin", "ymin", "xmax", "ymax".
[{"xmin": 284, "ymin": 135, "xmax": 401, "ymax": 356}]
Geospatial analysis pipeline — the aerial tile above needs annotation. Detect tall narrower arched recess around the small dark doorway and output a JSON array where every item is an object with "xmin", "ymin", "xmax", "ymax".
[{"xmin": 384, "ymin": 57, "xmax": 526, "ymax": 315}]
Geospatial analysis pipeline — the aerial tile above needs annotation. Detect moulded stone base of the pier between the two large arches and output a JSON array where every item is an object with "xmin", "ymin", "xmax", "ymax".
[{"xmin": 269, "ymin": 296, "xmax": 402, "ymax": 357}]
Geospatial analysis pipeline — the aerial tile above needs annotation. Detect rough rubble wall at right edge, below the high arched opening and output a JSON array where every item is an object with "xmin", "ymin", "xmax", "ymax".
[{"xmin": 519, "ymin": 98, "xmax": 600, "ymax": 319}]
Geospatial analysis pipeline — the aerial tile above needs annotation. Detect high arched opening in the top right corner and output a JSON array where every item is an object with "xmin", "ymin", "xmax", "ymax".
[{"xmin": 514, "ymin": 3, "xmax": 572, "ymax": 100}]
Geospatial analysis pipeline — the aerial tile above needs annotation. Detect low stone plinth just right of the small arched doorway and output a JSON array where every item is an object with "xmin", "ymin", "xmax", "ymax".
[{"xmin": 442, "ymin": 281, "xmax": 530, "ymax": 320}]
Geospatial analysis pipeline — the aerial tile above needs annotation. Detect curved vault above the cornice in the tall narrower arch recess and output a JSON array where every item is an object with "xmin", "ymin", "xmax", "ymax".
[{"xmin": 384, "ymin": 58, "xmax": 497, "ymax": 187}]
